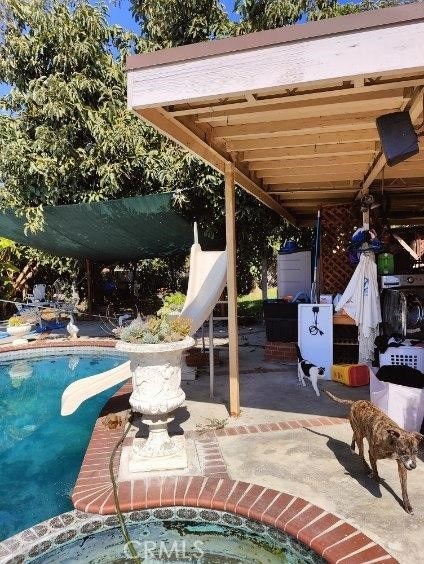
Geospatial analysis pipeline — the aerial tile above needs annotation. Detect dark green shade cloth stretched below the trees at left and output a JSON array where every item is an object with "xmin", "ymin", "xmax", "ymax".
[{"xmin": 0, "ymin": 193, "xmax": 193, "ymax": 262}]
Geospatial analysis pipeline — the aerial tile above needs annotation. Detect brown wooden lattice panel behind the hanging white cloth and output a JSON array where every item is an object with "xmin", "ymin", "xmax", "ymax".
[{"xmin": 320, "ymin": 204, "xmax": 358, "ymax": 294}]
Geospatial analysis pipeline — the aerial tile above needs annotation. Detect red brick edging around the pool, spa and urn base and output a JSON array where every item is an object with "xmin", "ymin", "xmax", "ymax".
[{"xmin": 72, "ymin": 383, "xmax": 397, "ymax": 564}]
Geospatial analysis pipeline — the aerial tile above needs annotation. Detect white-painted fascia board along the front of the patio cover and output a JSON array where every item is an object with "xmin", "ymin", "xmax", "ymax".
[{"xmin": 128, "ymin": 21, "xmax": 424, "ymax": 108}]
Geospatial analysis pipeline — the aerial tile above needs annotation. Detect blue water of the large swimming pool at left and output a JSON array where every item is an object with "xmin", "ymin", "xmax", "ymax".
[{"xmin": 0, "ymin": 353, "xmax": 125, "ymax": 540}]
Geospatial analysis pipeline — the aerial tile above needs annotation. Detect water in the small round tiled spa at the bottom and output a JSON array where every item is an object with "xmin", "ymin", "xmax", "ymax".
[{"xmin": 31, "ymin": 508, "xmax": 324, "ymax": 564}]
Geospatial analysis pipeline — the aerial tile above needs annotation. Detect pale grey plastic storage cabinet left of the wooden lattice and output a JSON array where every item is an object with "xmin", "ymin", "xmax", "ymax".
[{"xmin": 277, "ymin": 251, "xmax": 311, "ymax": 298}]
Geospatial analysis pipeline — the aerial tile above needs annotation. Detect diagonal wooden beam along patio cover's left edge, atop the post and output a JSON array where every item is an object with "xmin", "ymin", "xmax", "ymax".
[{"xmin": 135, "ymin": 108, "xmax": 296, "ymax": 224}]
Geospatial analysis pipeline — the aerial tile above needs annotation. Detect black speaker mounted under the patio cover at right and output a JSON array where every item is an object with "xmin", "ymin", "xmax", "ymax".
[{"xmin": 376, "ymin": 112, "xmax": 420, "ymax": 166}]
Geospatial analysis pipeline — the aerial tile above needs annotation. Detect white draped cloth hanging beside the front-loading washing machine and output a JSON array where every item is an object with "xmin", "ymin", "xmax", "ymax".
[{"xmin": 336, "ymin": 251, "xmax": 381, "ymax": 364}]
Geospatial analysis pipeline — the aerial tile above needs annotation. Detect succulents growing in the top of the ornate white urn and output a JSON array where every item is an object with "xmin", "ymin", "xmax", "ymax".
[{"xmin": 119, "ymin": 316, "xmax": 191, "ymax": 345}]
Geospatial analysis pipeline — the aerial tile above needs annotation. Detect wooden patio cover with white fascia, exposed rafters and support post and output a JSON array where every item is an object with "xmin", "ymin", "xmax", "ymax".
[{"xmin": 127, "ymin": 3, "xmax": 424, "ymax": 414}]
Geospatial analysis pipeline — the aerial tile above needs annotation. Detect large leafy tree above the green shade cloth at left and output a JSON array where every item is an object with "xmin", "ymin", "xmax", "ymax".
[{"xmin": 0, "ymin": 0, "xmax": 197, "ymax": 229}]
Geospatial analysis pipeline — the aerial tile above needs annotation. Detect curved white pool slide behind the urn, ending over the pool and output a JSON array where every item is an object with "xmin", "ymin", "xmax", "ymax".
[{"xmin": 61, "ymin": 242, "xmax": 227, "ymax": 415}]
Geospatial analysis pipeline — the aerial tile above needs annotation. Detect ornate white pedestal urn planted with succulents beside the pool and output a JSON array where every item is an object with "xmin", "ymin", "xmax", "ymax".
[{"xmin": 116, "ymin": 316, "xmax": 194, "ymax": 472}]
